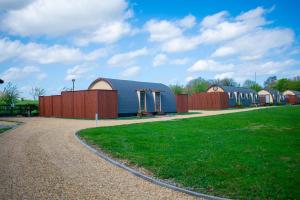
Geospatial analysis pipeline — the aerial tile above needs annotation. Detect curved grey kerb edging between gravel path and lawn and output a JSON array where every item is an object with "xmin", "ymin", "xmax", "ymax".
[{"xmin": 75, "ymin": 132, "xmax": 230, "ymax": 200}]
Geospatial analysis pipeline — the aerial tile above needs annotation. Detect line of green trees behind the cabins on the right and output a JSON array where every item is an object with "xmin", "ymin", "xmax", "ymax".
[{"xmin": 170, "ymin": 76, "xmax": 300, "ymax": 95}]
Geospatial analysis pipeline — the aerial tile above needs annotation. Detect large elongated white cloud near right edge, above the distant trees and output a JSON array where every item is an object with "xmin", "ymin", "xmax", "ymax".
[{"xmin": 212, "ymin": 29, "xmax": 294, "ymax": 60}]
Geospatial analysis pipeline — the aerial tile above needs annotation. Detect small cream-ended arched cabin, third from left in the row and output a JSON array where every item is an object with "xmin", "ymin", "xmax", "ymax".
[{"xmin": 258, "ymin": 88, "xmax": 285, "ymax": 105}]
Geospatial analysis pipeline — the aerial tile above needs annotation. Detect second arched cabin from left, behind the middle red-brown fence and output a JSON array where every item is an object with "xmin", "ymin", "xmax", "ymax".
[{"xmin": 206, "ymin": 85, "xmax": 259, "ymax": 107}]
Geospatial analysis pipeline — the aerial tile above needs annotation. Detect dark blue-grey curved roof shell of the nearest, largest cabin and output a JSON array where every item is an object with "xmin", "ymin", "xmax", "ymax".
[{"xmin": 90, "ymin": 78, "xmax": 176, "ymax": 114}]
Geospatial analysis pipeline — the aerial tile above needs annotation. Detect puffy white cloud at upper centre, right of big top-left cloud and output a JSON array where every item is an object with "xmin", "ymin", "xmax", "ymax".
[{"xmin": 145, "ymin": 20, "xmax": 182, "ymax": 42}]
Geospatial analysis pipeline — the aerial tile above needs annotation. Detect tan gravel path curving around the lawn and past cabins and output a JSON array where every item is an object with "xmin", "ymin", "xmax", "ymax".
[{"xmin": 0, "ymin": 108, "xmax": 264, "ymax": 200}]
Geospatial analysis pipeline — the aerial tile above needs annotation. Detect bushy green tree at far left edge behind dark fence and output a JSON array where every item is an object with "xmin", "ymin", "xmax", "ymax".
[{"xmin": 1, "ymin": 82, "xmax": 20, "ymax": 105}]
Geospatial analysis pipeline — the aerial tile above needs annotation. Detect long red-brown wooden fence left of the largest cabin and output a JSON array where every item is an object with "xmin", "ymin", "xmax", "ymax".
[{"xmin": 39, "ymin": 90, "xmax": 118, "ymax": 119}]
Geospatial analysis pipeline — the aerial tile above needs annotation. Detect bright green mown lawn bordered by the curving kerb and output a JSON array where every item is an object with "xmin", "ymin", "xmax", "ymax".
[{"xmin": 80, "ymin": 106, "xmax": 300, "ymax": 199}]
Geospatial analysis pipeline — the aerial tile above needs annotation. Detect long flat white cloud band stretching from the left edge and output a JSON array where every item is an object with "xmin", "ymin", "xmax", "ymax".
[{"xmin": 0, "ymin": 39, "xmax": 106, "ymax": 64}]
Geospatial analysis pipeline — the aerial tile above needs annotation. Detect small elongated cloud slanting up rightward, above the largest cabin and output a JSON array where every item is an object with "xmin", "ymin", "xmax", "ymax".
[{"xmin": 107, "ymin": 47, "xmax": 148, "ymax": 66}]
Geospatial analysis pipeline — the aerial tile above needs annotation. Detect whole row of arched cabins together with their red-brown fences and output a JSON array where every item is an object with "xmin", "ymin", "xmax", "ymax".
[{"xmin": 39, "ymin": 78, "xmax": 300, "ymax": 118}]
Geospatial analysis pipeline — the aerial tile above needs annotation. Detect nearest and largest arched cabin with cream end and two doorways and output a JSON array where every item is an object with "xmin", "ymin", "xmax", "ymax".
[{"xmin": 88, "ymin": 78, "xmax": 176, "ymax": 117}]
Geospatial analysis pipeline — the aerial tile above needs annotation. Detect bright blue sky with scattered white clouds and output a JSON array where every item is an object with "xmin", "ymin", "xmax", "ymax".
[{"xmin": 0, "ymin": 0, "xmax": 300, "ymax": 98}]
